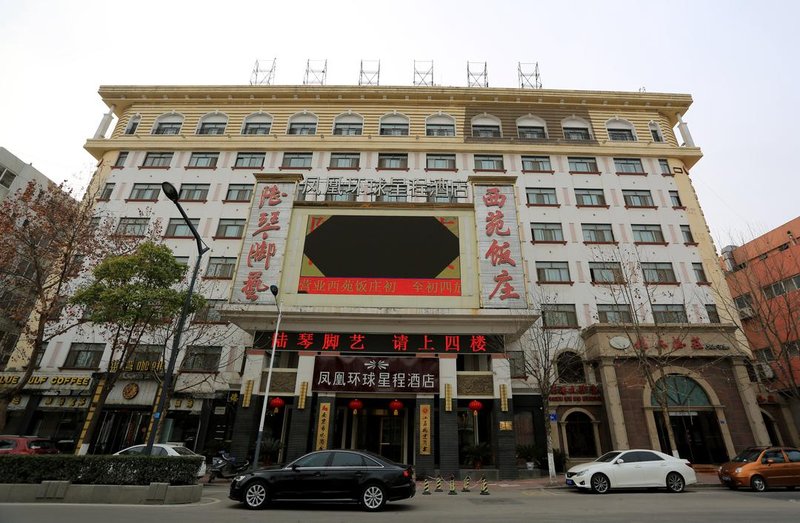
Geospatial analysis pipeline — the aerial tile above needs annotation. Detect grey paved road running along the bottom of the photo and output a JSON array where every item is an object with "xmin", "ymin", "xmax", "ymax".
[{"xmin": 0, "ymin": 485, "xmax": 800, "ymax": 523}]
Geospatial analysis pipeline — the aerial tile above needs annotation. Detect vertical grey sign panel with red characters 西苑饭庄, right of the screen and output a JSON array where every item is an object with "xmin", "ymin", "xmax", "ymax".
[{"xmin": 475, "ymin": 185, "xmax": 528, "ymax": 309}]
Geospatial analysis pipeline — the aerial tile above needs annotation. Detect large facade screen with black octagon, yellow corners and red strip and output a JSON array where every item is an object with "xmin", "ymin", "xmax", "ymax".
[{"xmin": 298, "ymin": 215, "xmax": 461, "ymax": 296}]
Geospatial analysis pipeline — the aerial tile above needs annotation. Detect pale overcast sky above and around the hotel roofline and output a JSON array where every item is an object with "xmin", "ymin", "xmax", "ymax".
[{"xmin": 0, "ymin": 0, "xmax": 800, "ymax": 248}]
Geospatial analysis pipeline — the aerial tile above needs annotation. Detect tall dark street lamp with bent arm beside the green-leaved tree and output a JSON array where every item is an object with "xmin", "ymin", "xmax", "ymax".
[{"xmin": 144, "ymin": 182, "xmax": 209, "ymax": 454}]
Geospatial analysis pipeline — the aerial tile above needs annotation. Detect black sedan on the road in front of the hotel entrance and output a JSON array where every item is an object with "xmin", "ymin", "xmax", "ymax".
[{"xmin": 229, "ymin": 450, "xmax": 417, "ymax": 511}]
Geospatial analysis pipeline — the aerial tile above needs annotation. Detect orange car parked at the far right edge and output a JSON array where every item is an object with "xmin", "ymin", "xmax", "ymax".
[{"xmin": 717, "ymin": 447, "xmax": 800, "ymax": 492}]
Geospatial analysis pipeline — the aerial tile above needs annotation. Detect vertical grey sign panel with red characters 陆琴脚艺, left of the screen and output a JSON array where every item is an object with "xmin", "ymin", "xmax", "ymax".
[{"xmin": 231, "ymin": 181, "xmax": 295, "ymax": 304}]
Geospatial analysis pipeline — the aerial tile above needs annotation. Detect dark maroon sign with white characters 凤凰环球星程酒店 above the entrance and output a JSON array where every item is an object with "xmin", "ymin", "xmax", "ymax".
[{"xmin": 311, "ymin": 356, "xmax": 439, "ymax": 393}]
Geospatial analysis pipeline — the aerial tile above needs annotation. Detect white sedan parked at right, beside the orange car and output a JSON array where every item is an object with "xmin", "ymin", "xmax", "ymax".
[{"xmin": 567, "ymin": 449, "xmax": 697, "ymax": 494}]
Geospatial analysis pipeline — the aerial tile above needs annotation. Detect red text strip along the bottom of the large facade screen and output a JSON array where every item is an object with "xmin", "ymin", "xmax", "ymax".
[{"xmin": 297, "ymin": 276, "xmax": 461, "ymax": 296}]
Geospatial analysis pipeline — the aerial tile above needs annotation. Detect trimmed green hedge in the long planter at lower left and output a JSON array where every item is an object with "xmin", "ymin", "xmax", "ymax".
[{"xmin": 0, "ymin": 454, "xmax": 203, "ymax": 485}]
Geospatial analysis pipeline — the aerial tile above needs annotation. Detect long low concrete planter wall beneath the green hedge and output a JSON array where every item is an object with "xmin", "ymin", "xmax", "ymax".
[{"xmin": 0, "ymin": 481, "xmax": 203, "ymax": 505}]
